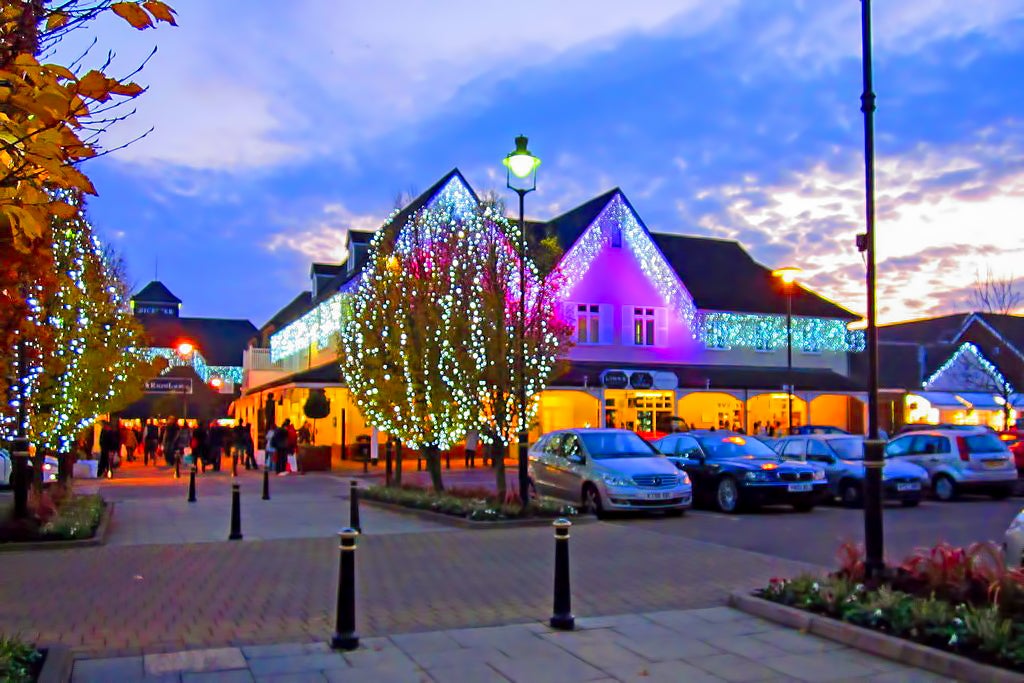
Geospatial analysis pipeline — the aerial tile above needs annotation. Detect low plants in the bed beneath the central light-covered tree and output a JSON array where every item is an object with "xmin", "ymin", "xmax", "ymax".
[{"xmin": 359, "ymin": 484, "xmax": 580, "ymax": 521}]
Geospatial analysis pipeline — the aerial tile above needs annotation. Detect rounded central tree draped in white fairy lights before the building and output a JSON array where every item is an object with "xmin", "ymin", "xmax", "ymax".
[{"xmin": 341, "ymin": 194, "xmax": 561, "ymax": 490}]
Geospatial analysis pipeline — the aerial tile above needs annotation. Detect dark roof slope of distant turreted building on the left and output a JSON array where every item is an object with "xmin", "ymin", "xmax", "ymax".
[{"xmin": 139, "ymin": 315, "xmax": 256, "ymax": 366}]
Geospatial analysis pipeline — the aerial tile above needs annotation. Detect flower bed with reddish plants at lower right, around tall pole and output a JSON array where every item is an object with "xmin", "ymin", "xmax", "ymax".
[{"xmin": 757, "ymin": 543, "xmax": 1024, "ymax": 673}]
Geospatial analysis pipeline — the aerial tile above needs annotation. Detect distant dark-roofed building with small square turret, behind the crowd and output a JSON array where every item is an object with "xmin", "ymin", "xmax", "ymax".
[{"xmin": 119, "ymin": 281, "xmax": 257, "ymax": 419}]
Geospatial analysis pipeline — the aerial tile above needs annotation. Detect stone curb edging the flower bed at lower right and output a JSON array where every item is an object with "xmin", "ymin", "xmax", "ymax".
[{"xmin": 729, "ymin": 593, "xmax": 1021, "ymax": 683}]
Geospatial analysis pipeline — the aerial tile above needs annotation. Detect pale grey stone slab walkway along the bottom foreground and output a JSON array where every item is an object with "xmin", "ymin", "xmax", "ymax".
[{"xmin": 73, "ymin": 607, "xmax": 945, "ymax": 683}]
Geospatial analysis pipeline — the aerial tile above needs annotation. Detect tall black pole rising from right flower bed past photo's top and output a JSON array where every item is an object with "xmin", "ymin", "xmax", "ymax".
[{"xmin": 860, "ymin": 0, "xmax": 885, "ymax": 578}]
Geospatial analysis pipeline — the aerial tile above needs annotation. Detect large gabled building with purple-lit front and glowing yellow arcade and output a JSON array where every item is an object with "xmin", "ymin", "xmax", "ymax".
[{"xmin": 236, "ymin": 164, "xmax": 865, "ymax": 454}]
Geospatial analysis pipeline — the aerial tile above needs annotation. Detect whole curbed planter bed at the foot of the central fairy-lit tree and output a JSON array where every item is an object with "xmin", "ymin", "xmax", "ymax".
[{"xmin": 359, "ymin": 486, "xmax": 590, "ymax": 528}]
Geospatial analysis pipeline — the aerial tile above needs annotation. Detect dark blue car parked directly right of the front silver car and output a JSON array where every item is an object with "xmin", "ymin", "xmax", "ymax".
[{"xmin": 654, "ymin": 430, "xmax": 827, "ymax": 513}]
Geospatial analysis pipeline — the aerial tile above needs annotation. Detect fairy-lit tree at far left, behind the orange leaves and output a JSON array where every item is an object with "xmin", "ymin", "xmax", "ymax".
[{"xmin": 0, "ymin": 198, "xmax": 153, "ymax": 471}]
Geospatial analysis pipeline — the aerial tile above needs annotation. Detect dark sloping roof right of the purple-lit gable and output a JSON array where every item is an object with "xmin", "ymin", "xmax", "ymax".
[{"xmin": 650, "ymin": 232, "xmax": 860, "ymax": 321}]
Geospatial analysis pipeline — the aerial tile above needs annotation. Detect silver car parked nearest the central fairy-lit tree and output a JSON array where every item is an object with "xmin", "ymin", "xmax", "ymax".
[{"xmin": 528, "ymin": 429, "xmax": 693, "ymax": 517}]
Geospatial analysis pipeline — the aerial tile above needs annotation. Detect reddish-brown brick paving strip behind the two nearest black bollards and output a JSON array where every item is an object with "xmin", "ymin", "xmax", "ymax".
[{"xmin": 0, "ymin": 523, "xmax": 808, "ymax": 654}]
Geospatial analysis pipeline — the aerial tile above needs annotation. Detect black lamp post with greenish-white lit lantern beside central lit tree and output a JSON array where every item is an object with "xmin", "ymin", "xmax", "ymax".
[{"xmin": 502, "ymin": 135, "xmax": 541, "ymax": 510}]
